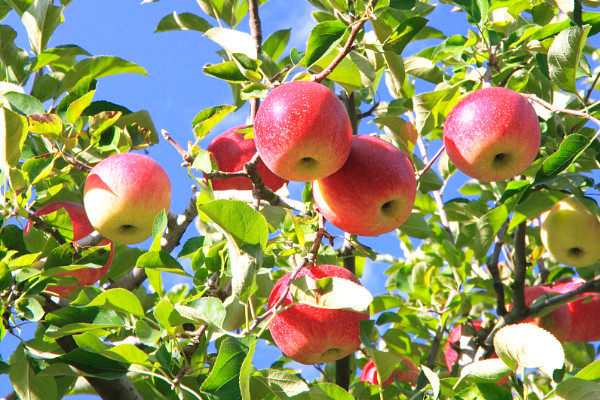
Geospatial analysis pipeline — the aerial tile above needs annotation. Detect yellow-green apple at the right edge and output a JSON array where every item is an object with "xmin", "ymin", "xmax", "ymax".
[{"xmin": 540, "ymin": 197, "xmax": 600, "ymax": 268}]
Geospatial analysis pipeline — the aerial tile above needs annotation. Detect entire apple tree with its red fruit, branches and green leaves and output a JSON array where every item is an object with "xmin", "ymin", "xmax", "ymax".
[{"xmin": 0, "ymin": 0, "xmax": 600, "ymax": 400}]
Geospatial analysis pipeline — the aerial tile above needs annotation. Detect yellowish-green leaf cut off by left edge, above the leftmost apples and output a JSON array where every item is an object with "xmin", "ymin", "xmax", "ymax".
[{"xmin": 0, "ymin": 107, "xmax": 27, "ymax": 175}]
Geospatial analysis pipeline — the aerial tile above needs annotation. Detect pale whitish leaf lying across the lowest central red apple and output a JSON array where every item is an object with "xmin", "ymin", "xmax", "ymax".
[{"xmin": 290, "ymin": 276, "xmax": 373, "ymax": 313}]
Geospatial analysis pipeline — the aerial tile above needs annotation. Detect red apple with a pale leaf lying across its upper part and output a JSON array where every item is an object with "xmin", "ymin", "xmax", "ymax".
[{"xmin": 268, "ymin": 264, "xmax": 369, "ymax": 365}]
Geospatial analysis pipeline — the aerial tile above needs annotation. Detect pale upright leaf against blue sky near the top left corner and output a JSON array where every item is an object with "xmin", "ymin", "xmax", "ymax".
[{"xmin": 21, "ymin": 0, "xmax": 64, "ymax": 54}]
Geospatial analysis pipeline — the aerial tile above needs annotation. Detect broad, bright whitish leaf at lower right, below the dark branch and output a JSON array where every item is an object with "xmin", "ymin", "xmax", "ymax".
[{"xmin": 494, "ymin": 324, "xmax": 565, "ymax": 377}]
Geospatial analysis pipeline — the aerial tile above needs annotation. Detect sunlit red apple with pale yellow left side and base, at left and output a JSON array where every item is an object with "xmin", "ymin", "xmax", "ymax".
[{"xmin": 83, "ymin": 153, "xmax": 171, "ymax": 244}]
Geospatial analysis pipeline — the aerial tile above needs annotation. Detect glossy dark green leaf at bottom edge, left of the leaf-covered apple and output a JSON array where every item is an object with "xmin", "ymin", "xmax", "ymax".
[{"xmin": 201, "ymin": 337, "xmax": 256, "ymax": 400}]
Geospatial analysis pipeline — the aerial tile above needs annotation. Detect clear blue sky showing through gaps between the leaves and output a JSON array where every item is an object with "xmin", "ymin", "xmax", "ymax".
[{"xmin": 0, "ymin": 0, "xmax": 596, "ymax": 399}]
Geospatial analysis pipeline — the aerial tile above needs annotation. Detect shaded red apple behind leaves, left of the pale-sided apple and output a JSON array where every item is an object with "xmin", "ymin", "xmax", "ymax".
[{"xmin": 23, "ymin": 201, "xmax": 115, "ymax": 296}]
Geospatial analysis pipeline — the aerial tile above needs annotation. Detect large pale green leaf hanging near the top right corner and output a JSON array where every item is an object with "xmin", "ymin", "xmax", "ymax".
[{"xmin": 548, "ymin": 25, "xmax": 591, "ymax": 93}]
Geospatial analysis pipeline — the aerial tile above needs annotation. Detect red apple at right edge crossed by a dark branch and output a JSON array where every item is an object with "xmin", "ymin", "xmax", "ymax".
[{"xmin": 525, "ymin": 278, "xmax": 600, "ymax": 342}]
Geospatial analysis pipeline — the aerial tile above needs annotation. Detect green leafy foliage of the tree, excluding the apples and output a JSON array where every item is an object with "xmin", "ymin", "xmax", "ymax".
[{"xmin": 0, "ymin": 0, "xmax": 600, "ymax": 400}]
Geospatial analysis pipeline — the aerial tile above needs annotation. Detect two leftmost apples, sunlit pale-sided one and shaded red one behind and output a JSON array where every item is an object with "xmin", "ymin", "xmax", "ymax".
[{"xmin": 29, "ymin": 153, "xmax": 171, "ymax": 296}]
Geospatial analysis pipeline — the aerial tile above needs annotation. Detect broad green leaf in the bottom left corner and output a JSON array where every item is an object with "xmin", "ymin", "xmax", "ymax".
[{"xmin": 8, "ymin": 344, "xmax": 57, "ymax": 400}]
